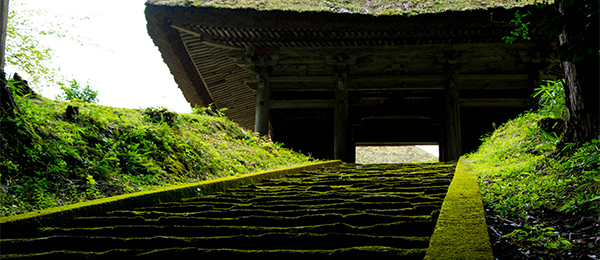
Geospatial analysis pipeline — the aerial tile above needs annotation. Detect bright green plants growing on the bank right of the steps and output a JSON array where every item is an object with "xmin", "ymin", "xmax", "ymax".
[{"xmin": 468, "ymin": 82, "xmax": 600, "ymax": 253}]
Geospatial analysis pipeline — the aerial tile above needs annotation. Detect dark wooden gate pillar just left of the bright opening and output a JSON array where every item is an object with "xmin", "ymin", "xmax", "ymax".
[{"xmin": 333, "ymin": 73, "xmax": 355, "ymax": 162}]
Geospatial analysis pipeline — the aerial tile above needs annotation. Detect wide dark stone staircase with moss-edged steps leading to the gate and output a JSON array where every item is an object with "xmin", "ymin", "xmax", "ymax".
[{"xmin": 0, "ymin": 163, "xmax": 456, "ymax": 260}]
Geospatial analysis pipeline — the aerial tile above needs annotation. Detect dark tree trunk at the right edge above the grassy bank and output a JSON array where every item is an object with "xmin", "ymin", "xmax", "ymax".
[{"xmin": 559, "ymin": 4, "xmax": 600, "ymax": 144}]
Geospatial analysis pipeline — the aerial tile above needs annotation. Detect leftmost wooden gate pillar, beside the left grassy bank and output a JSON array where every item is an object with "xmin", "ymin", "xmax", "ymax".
[{"xmin": 254, "ymin": 70, "xmax": 271, "ymax": 135}]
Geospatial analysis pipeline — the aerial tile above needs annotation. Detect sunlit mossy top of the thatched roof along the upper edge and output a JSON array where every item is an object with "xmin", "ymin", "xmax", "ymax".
[{"xmin": 149, "ymin": 0, "xmax": 535, "ymax": 15}]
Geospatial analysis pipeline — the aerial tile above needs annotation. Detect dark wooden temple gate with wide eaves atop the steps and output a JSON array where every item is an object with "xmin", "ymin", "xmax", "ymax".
[{"xmin": 146, "ymin": 4, "xmax": 558, "ymax": 162}]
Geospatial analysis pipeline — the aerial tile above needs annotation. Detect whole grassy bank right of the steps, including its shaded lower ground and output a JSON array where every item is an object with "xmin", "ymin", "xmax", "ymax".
[{"xmin": 468, "ymin": 79, "xmax": 600, "ymax": 259}]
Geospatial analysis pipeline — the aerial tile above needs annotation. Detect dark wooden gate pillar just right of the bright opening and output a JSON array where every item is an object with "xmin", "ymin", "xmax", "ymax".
[{"xmin": 440, "ymin": 64, "xmax": 462, "ymax": 162}]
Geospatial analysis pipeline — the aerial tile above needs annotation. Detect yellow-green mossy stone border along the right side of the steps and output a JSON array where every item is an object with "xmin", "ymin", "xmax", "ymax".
[{"xmin": 425, "ymin": 157, "xmax": 494, "ymax": 260}]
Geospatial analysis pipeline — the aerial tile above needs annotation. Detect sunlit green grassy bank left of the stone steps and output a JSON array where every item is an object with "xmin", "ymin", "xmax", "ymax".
[{"xmin": 0, "ymin": 84, "xmax": 312, "ymax": 216}]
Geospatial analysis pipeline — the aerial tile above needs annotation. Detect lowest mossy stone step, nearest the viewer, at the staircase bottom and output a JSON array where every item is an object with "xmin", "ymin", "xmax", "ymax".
[{"xmin": 2, "ymin": 232, "xmax": 429, "ymax": 254}]
